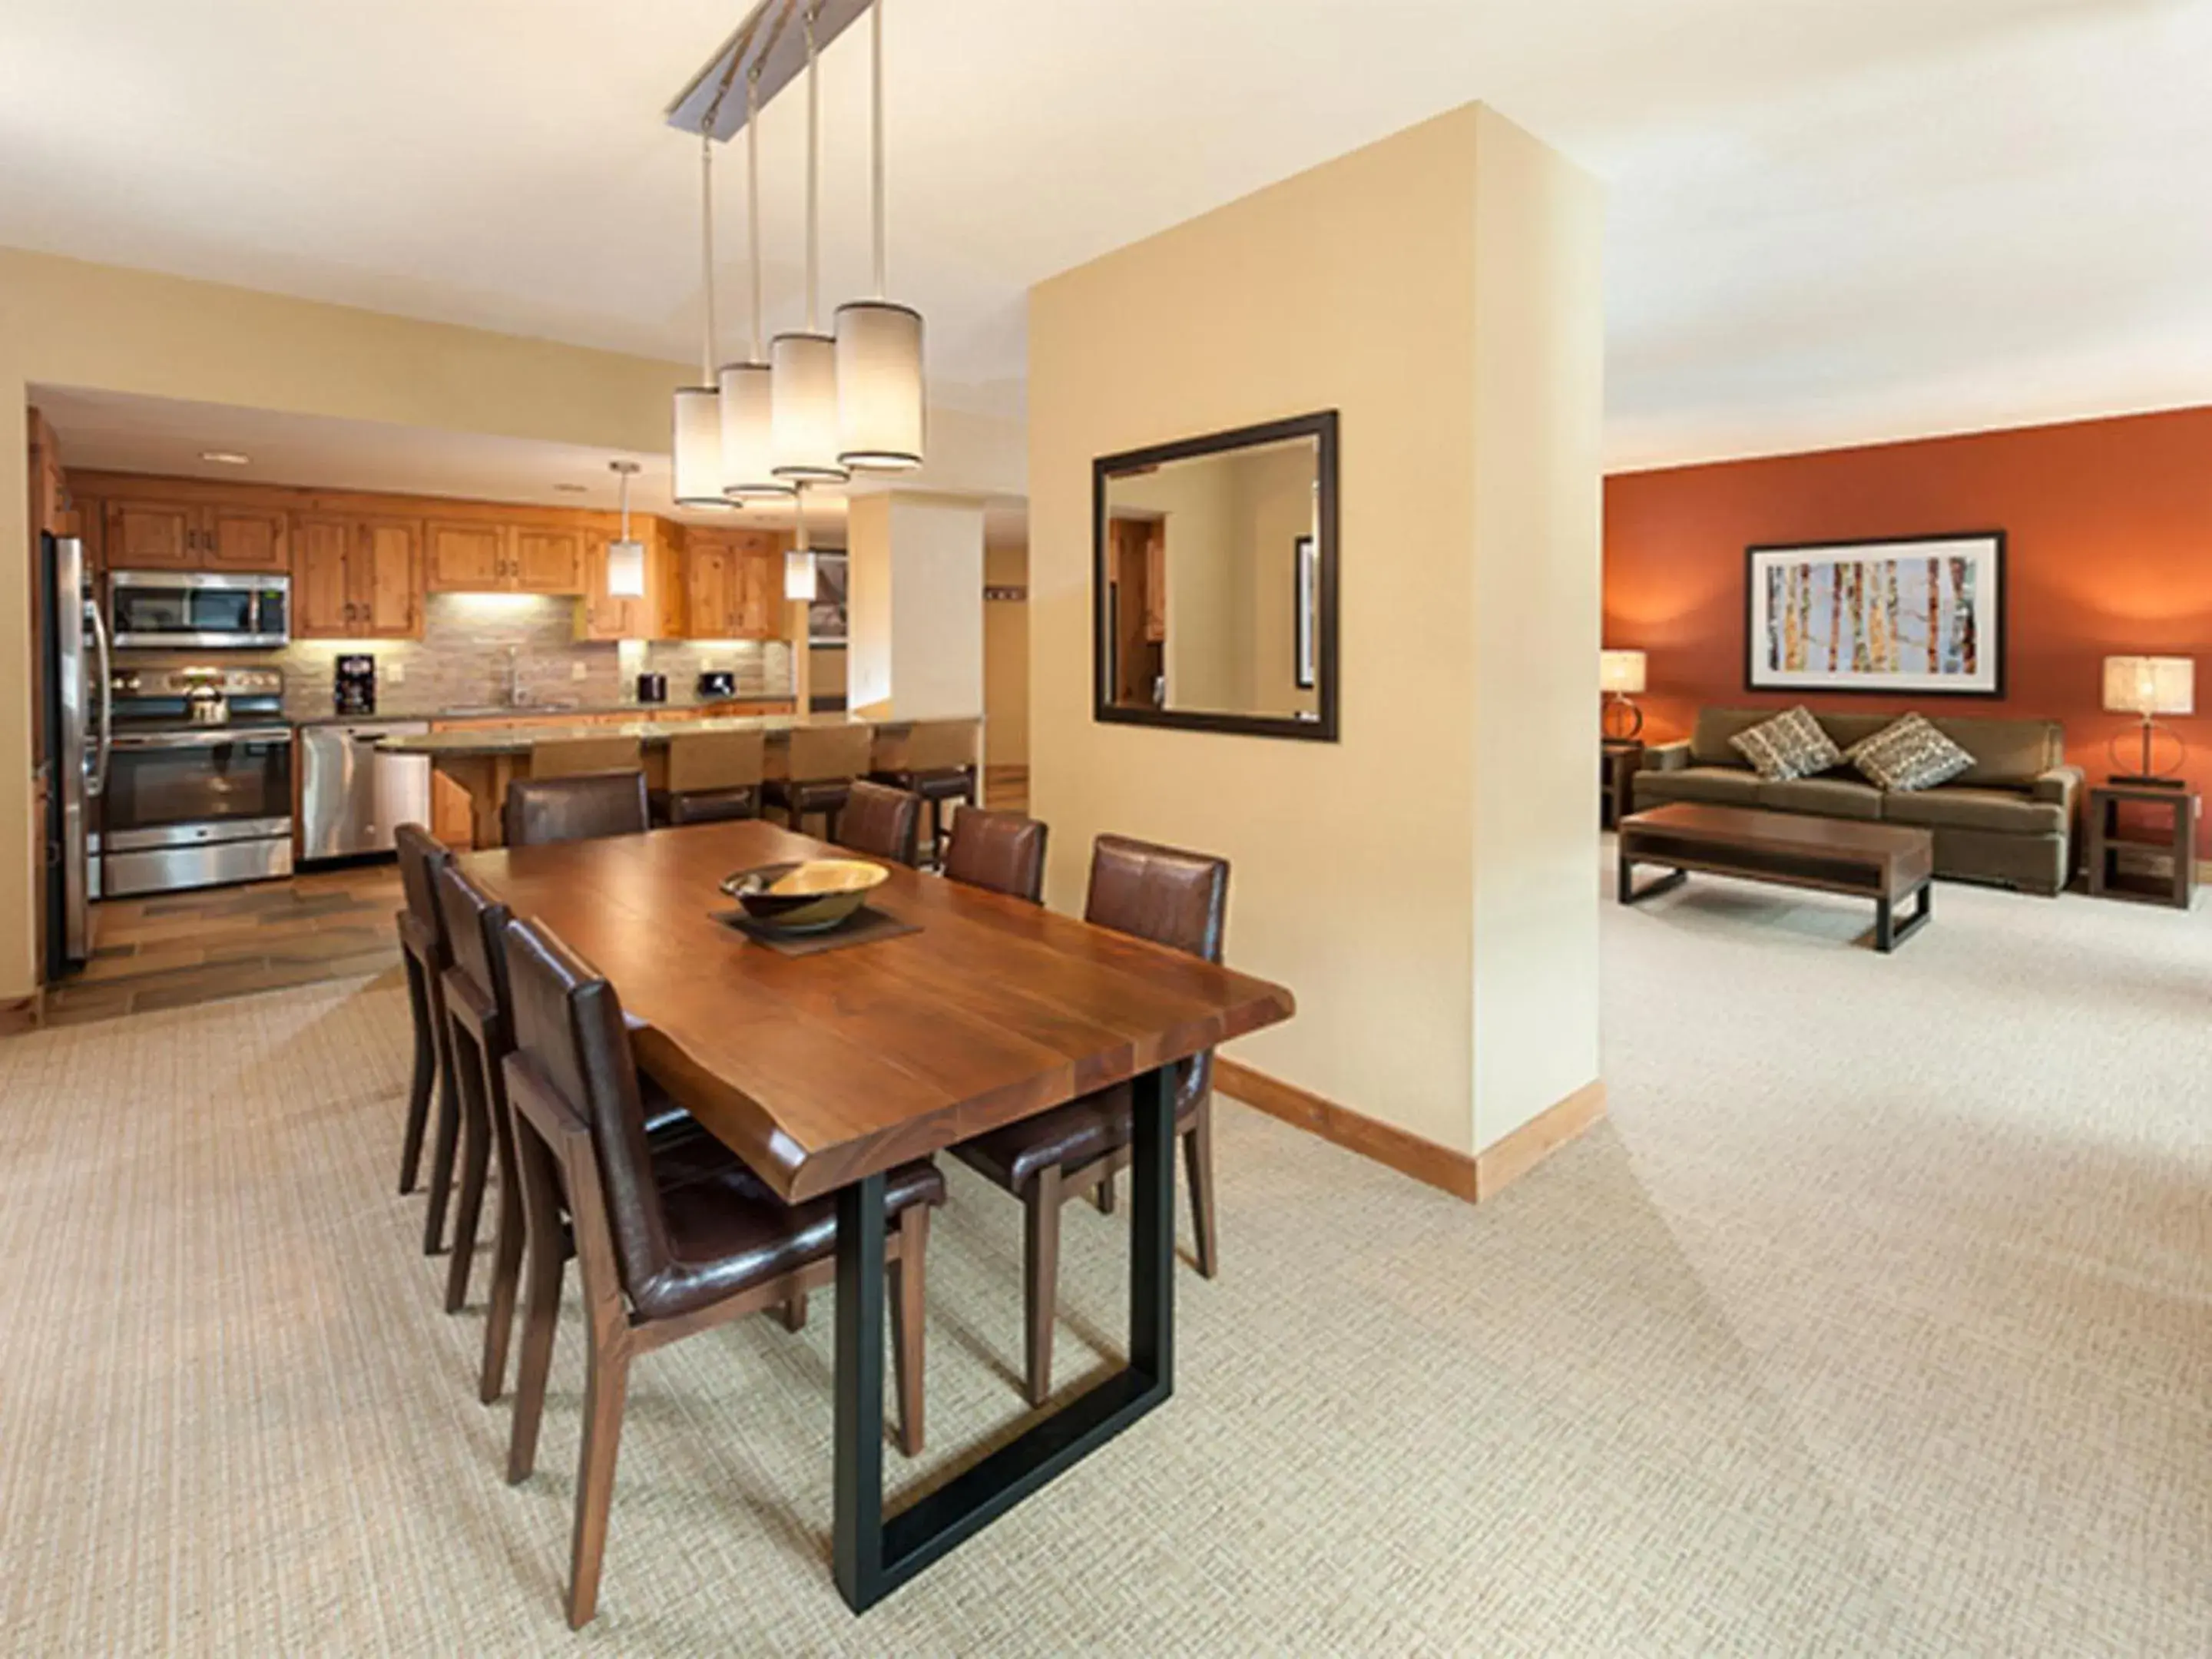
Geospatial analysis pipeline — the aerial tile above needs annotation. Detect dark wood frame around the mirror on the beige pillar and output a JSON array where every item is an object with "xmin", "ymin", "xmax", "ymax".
[{"xmin": 1091, "ymin": 409, "xmax": 1338, "ymax": 743}]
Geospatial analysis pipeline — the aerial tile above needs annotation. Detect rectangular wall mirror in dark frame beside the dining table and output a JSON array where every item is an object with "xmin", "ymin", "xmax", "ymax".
[{"xmin": 1091, "ymin": 409, "xmax": 1336, "ymax": 743}]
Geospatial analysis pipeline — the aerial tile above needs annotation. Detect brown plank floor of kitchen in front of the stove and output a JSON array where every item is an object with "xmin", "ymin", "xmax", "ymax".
[{"xmin": 42, "ymin": 863, "xmax": 400, "ymax": 1026}]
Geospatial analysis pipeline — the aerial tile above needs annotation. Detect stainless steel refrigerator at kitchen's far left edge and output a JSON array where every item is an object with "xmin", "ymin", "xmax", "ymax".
[{"xmin": 38, "ymin": 535, "xmax": 113, "ymax": 982}]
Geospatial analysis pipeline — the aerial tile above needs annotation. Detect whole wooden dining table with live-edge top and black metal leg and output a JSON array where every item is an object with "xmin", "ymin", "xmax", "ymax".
[{"xmin": 462, "ymin": 820, "xmax": 1294, "ymax": 1613}]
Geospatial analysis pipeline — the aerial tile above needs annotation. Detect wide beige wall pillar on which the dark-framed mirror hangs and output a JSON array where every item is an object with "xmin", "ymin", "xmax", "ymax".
[{"xmin": 1028, "ymin": 106, "xmax": 1597, "ymax": 1152}]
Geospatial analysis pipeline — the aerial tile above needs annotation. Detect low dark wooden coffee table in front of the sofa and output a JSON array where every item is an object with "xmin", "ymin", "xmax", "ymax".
[{"xmin": 1619, "ymin": 801, "xmax": 1936, "ymax": 951}]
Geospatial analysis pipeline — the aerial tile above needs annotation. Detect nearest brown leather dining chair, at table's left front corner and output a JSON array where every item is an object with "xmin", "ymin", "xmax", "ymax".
[{"xmin": 507, "ymin": 922, "xmax": 945, "ymax": 1628}]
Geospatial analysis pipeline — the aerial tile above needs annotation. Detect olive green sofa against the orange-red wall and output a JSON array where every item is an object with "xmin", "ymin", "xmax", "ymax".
[{"xmin": 1632, "ymin": 708, "xmax": 2084, "ymax": 896}]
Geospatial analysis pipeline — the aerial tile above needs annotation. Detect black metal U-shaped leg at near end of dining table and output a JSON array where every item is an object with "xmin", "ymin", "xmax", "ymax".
[{"xmin": 834, "ymin": 1066, "xmax": 1174, "ymax": 1613}]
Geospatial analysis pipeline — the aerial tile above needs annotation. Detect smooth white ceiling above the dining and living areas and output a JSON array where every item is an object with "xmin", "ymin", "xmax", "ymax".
[{"xmin": 0, "ymin": 0, "xmax": 2212, "ymax": 465}]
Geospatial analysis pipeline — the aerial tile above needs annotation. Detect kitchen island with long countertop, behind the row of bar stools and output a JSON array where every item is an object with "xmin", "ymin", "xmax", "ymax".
[{"xmin": 376, "ymin": 708, "xmax": 982, "ymax": 849}]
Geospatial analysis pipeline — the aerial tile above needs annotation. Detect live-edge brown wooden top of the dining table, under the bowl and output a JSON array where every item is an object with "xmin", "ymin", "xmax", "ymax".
[{"xmin": 460, "ymin": 820, "xmax": 1294, "ymax": 1201}]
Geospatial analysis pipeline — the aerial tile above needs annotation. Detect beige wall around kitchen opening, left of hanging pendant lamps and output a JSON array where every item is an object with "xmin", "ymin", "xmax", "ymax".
[{"xmin": 0, "ymin": 250, "xmax": 688, "ymax": 1002}]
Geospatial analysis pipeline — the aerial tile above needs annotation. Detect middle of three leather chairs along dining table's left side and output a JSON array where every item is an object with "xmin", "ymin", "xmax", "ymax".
[{"xmin": 424, "ymin": 863, "xmax": 726, "ymax": 1405}]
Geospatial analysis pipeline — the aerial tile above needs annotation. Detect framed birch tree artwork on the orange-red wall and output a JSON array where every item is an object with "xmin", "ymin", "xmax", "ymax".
[{"xmin": 1743, "ymin": 531, "xmax": 2006, "ymax": 697}]
